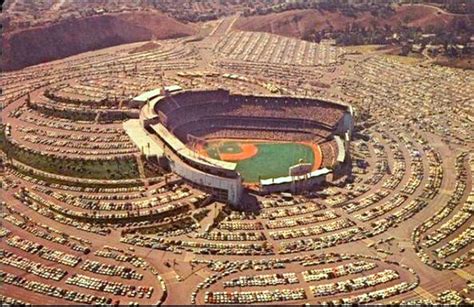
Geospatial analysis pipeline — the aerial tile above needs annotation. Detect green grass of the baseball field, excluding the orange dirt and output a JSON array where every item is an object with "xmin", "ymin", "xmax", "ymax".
[{"xmin": 206, "ymin": 142, "xmax": 314, "ymax": 183}]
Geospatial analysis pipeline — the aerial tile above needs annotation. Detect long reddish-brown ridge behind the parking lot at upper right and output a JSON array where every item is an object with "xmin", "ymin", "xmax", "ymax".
[{"xmin": 234, "ymin": 5, "xmax": 474, "ymax": 38}]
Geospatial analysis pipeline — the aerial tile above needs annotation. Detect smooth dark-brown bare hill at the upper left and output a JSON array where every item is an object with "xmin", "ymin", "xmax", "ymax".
[{"xmin": 1, "ymin": 12, "xmax": 196, "ymax": 70}]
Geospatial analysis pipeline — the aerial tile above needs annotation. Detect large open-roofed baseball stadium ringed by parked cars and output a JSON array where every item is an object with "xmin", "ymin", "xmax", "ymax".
[{"xmin": 141, "ymin": 89, "xmax": 353, "ymax": 208}]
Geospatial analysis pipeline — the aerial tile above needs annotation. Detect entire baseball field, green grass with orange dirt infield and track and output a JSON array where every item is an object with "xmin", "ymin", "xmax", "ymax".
[{"xmin": 197, "ymin": 140, "xmax": 321, "ymax": 183}]
